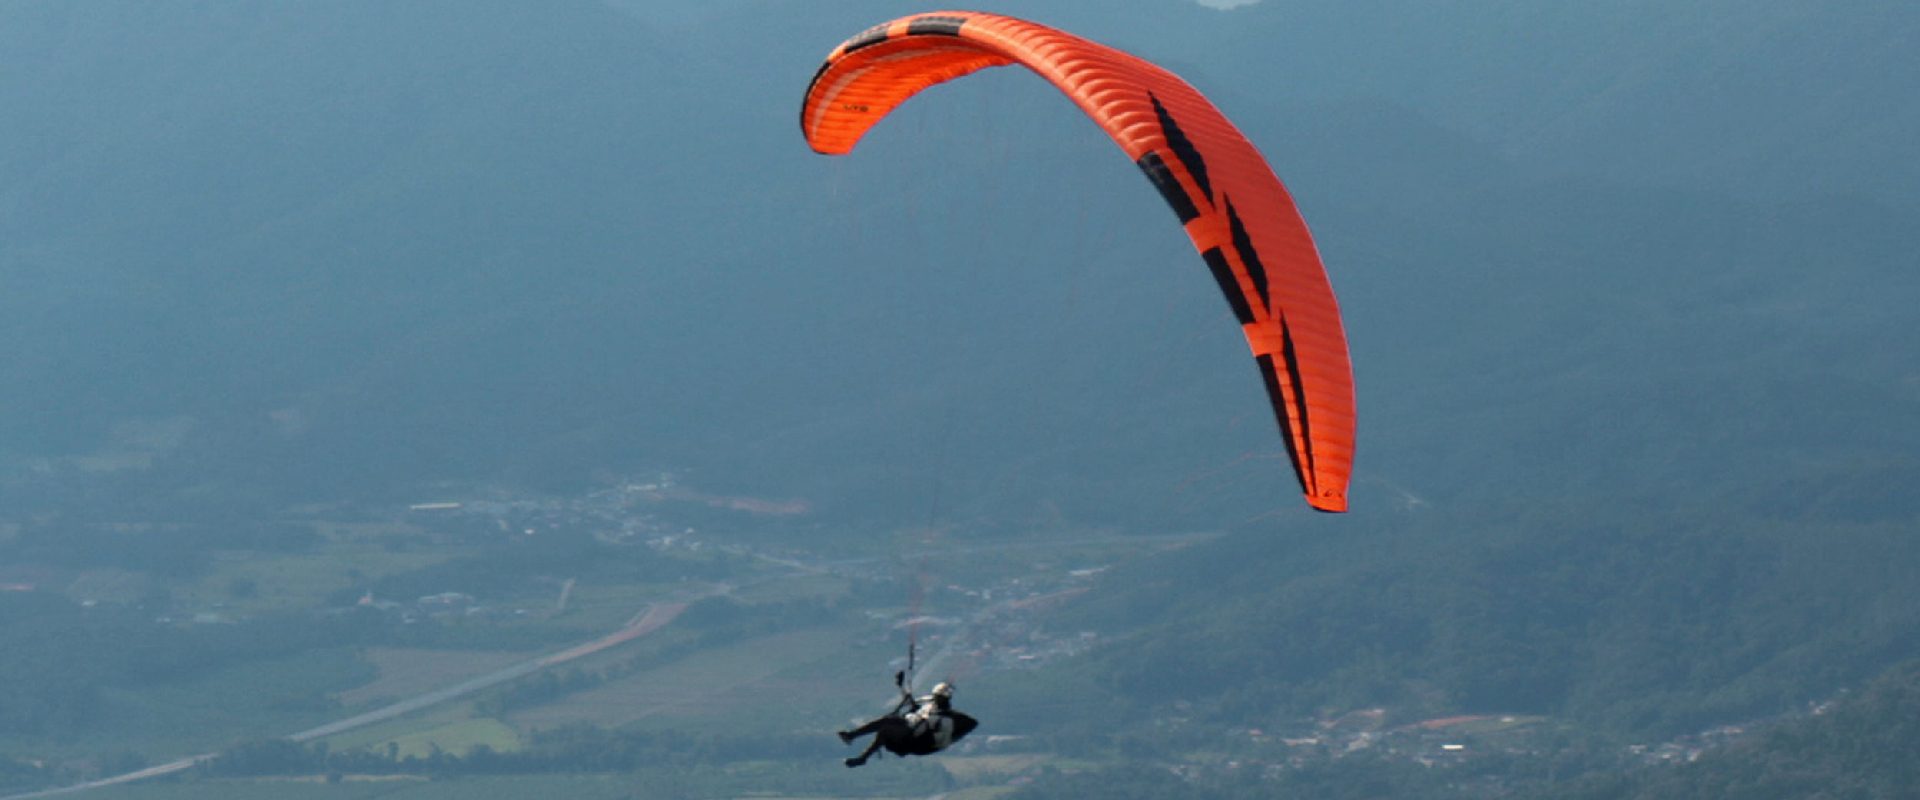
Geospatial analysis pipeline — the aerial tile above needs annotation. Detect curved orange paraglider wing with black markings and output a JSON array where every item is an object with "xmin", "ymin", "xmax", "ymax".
[{"xmin": 801, "ymin": 12, "xmax": 1354, "ymax": 512}]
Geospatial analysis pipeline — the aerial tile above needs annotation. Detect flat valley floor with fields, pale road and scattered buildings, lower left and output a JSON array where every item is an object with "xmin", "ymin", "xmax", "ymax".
[{"xmin": 0, "ymin": 479, "xmax": 1179, "ymax": 800}]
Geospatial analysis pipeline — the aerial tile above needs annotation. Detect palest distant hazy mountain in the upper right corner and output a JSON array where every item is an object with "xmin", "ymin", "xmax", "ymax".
[{"xmin": 1213, "ymin": 2, "xmax": 1920, "ymax": 207}]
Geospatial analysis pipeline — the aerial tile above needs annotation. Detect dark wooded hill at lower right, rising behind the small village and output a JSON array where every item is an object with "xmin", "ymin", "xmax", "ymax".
[{"xmin": 1052, "ymin": 505, "xmax": 1920, "ymax": 737}]
